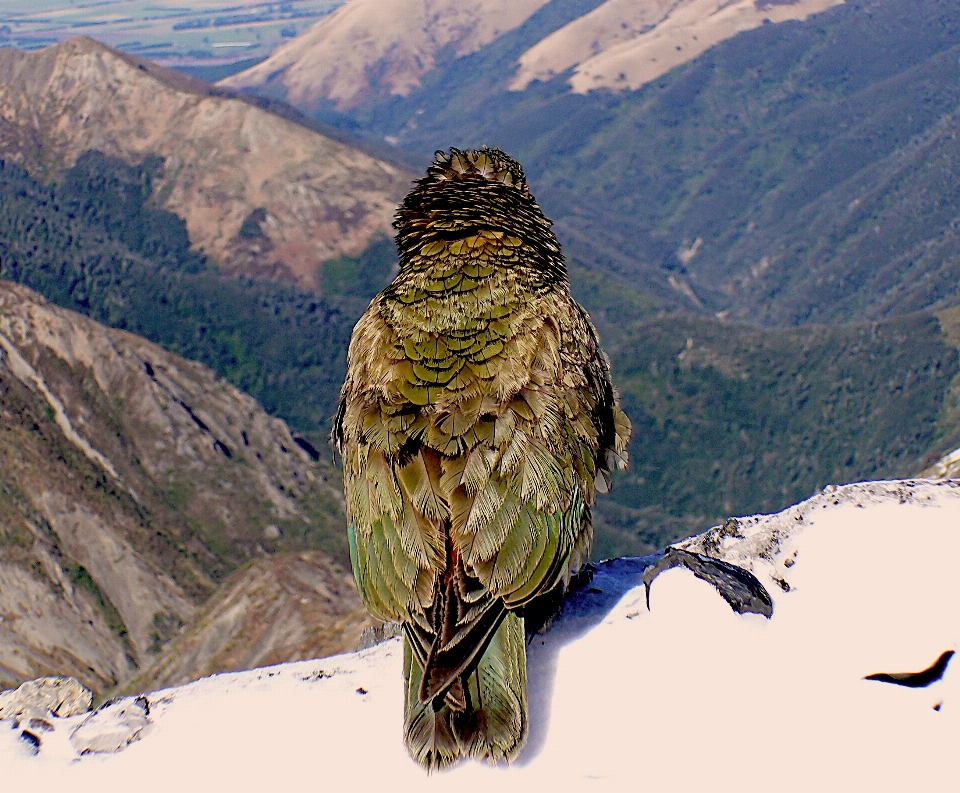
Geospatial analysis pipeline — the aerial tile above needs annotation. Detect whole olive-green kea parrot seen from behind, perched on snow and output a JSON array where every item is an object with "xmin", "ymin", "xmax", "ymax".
[{"xmin": 333, "ymin": 148, "xmax": 631, "ymax": 770}]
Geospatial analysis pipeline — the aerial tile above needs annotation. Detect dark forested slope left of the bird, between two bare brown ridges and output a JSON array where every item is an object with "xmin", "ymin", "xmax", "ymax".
[{"xmin": 0, "ymin": 153, "xmax": 393, "ymax": 442}]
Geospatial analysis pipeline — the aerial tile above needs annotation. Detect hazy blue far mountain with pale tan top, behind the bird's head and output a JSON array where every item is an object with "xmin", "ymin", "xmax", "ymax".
[{"xmin": 226, "ymin": 0, "xmax": 960, "ymax": 325}]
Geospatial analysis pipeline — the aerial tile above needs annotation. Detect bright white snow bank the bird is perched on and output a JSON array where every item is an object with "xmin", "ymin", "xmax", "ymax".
[{"xmin": 0, "ymin": 480, "xmax": 960, "ymax": 793}]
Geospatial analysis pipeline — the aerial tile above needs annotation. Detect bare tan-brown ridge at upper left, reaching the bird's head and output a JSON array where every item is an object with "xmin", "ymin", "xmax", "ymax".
[{"xmin": 0, "ymin": 37, "xmax": 413, "ymax": 288}]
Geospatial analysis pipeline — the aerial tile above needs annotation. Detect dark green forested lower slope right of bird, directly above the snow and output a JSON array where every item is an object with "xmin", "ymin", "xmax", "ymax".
[{"xmin": 597, "ymin": 314, "xmax": 960, "ymax": 556}]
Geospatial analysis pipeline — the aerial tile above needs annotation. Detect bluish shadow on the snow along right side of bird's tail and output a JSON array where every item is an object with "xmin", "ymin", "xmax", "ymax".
[{"xmin": 515, "ymin": 553, "xmax": 663, "ymax": 766}]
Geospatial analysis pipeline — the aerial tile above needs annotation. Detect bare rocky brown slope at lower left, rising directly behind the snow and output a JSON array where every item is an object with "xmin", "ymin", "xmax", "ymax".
[{"xmin": 0, "ymin": 282, "xmax": 366, "ymax": 692}]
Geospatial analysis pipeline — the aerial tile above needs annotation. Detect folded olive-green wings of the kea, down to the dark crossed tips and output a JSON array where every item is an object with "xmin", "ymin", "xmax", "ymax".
[{"xmin": 335, "ymin": 294, "xmax": 629, "ymax": 701}]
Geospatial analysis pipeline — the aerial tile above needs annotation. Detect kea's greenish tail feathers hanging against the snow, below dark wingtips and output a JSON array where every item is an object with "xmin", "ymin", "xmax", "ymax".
[{"xmin": 403, "ymin": 612, "xmax": 527, "ymax": 770}]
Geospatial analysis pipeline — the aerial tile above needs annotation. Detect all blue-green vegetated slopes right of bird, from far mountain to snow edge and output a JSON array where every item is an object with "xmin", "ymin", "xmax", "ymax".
[{"xmin": 286, "ymin": 0, "xmax": 960, "ymax": 556}]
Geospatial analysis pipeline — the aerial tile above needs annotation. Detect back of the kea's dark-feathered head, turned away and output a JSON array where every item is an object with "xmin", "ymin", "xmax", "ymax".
[{"xmin": 393, "ymin": 147, "xmax": 567, "ymax": 282}]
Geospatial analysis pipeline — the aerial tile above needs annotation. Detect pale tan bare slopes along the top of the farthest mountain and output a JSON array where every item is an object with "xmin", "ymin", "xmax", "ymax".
[{"xmin": 220, "ymin": 0, "xmax": 843, "ymax": 112}]
